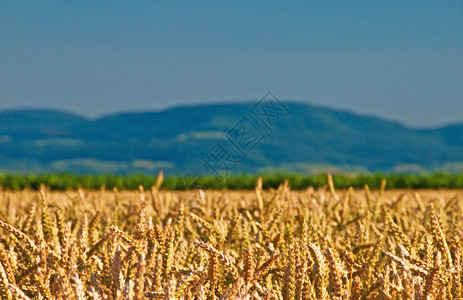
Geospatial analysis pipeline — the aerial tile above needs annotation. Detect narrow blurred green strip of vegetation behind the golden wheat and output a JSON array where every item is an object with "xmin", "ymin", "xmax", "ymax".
[{"xmin": 0, "ymin": 173, "xmax": 463, "ymax": 190}]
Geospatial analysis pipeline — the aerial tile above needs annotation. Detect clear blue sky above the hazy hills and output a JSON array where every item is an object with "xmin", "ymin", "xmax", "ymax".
[{"xmin": 0, "ymin": 0, "xmax": 463, "ymax": 127}]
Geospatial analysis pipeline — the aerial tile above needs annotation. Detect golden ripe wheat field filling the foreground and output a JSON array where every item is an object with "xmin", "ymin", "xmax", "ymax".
[{"xmin": 0, "ymin": 175, "xmax": 463, "ymax": 299}]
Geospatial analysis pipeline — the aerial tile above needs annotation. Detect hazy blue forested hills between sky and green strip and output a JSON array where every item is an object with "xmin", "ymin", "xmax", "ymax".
[{"xmin": 0, "ymin": 103, "xmax": 463, "ymax": 173}]
